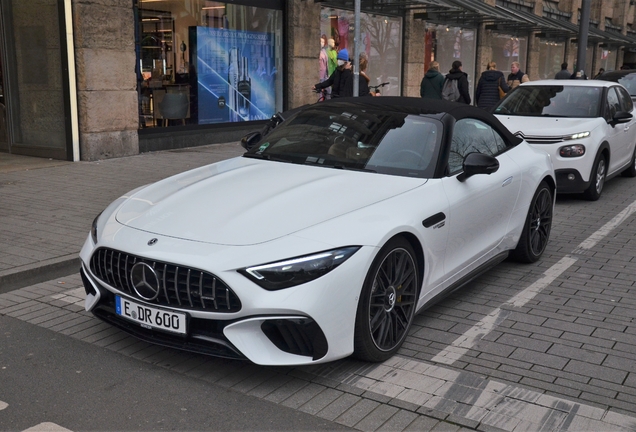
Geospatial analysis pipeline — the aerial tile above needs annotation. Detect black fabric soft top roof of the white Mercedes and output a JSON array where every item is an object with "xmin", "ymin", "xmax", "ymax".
[{"xmin": 306, "ymin": 96, "xmax": 522, "ymax": 145}]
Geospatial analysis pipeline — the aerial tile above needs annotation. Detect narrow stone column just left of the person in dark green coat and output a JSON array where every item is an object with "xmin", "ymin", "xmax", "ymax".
[{"xmin": 402, "ymin": 11, "xmax": 426, "ymax": 97}]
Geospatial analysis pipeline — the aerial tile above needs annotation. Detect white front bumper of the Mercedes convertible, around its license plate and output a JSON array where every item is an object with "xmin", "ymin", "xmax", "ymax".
[{"xmin": 80, "ymin": 230, "xmax": 375, "ymax": 365}]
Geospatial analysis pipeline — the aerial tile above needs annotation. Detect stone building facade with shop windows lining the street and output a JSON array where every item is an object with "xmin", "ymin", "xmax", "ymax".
[{"xmin": 0, "ymin": 0, "xmax": 636, "ymax": 160}]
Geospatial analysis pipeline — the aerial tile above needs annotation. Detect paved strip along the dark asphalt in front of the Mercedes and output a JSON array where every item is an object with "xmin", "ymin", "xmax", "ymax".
[{"xmin": 0, "ymin": 274, "xmax": 636, "ymax": 432}]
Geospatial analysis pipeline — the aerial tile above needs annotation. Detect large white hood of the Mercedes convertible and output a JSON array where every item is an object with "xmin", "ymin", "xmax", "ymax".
[{"xmin": 115, "ymin": 157, "xmax": 426, "ymax": 245}]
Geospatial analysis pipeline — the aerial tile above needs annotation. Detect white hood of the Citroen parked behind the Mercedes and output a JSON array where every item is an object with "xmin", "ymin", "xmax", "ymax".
[{"xmin": 495, "ymin": 114, "xmax": 605, "ymax": 137}]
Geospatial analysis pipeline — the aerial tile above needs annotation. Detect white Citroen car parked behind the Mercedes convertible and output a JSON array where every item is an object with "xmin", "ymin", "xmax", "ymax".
[{"xmin": 493, "ymin": 80, "xmax": 636, "ymax": 201}]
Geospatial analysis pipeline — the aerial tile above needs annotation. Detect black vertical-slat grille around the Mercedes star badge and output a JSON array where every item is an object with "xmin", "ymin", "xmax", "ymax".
[{"xmin": 91, "ymin": 248, "xmax": 241, "ymax": 313}]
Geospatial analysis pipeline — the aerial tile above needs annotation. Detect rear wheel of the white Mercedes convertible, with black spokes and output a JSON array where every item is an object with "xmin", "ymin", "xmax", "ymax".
[{"xmin": 511, "ymin": 182, "xmax": 554, "ymax": 263}]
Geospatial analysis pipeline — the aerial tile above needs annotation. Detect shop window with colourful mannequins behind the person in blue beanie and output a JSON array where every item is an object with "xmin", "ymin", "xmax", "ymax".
[{"xmin": 316, "ymin": 7, "xmax": 402, "ymax": 96}]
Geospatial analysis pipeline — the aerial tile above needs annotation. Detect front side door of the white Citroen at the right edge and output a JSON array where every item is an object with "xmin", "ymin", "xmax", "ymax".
[{"xmin": 606, "ymin": 86, "xmax": 634, "ymax": 174}]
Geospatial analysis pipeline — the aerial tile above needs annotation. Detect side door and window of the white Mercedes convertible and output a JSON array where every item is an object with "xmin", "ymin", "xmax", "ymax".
[{"xmin": 442, "ymin": 118, "xmax": 521, "ymax": 285}]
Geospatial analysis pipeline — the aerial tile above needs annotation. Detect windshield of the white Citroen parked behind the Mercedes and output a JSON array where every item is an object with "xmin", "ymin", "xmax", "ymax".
[{"xmin": 495, "ymin": 85, "xmax": 603, "ymax": 118}]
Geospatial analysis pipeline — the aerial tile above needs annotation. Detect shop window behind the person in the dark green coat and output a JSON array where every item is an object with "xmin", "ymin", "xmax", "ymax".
[{"xmin": 425, "ymin": 25, "xmax": 477, "ymax": 98}]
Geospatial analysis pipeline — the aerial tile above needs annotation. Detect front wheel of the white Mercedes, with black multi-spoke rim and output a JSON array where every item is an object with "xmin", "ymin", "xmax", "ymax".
[{"xmin": 353, "ymin": 237, "xmax": 420, "ymax": 362}]
